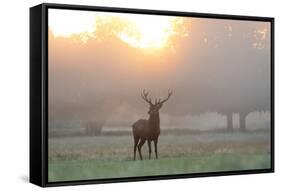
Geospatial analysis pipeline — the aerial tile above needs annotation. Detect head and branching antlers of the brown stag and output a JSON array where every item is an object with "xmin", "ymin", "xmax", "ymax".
[{"xmin": 141, "ymin": 90, "xmax": 173, "ymax": 115}]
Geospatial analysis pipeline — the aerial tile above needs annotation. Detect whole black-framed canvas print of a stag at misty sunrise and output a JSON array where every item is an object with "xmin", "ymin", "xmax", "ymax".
[{"xmin": 30, "ymin": 4, "xmax": 274, "ymax": 186}]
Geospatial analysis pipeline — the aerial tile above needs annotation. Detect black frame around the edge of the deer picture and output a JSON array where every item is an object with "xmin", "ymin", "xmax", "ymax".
[{"xmin": 30, "ymin": 3, "xmax": 274, "ymax": 187}]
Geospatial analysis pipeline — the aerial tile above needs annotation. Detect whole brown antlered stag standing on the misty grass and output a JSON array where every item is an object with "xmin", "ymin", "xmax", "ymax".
[{"xmin": 132, "ymin": 90, "xmax": 172, "ymax": 160}]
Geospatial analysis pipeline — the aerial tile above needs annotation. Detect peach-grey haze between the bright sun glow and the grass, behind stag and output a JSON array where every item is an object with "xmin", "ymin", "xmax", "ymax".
[{"xmin": 48, "ymin": 18, "xmax": 270, "ymax": 129}]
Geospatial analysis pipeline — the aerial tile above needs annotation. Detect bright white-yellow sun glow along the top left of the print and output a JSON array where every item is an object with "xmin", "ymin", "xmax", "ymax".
[{"xmin": 49, "ymin": 9, "xmax": 184, "ymax": 49}]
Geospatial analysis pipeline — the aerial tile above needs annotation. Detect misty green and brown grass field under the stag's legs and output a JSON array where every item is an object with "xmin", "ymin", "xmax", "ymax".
[{"xmin": 48, "ymin": 131, "xmax": 270, "ymax": 182}]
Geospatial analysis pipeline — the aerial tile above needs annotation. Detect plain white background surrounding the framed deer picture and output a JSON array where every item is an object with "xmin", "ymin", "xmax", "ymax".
[{"xmin": 0, "ymin": 0, "xmax": 281, "ymax": 191}]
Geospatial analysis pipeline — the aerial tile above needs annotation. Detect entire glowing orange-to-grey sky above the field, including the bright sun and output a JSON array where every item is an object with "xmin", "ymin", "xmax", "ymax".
[{"xmin": 48, "ymin": 9, "xmax": 270, "ymax": 128}]
